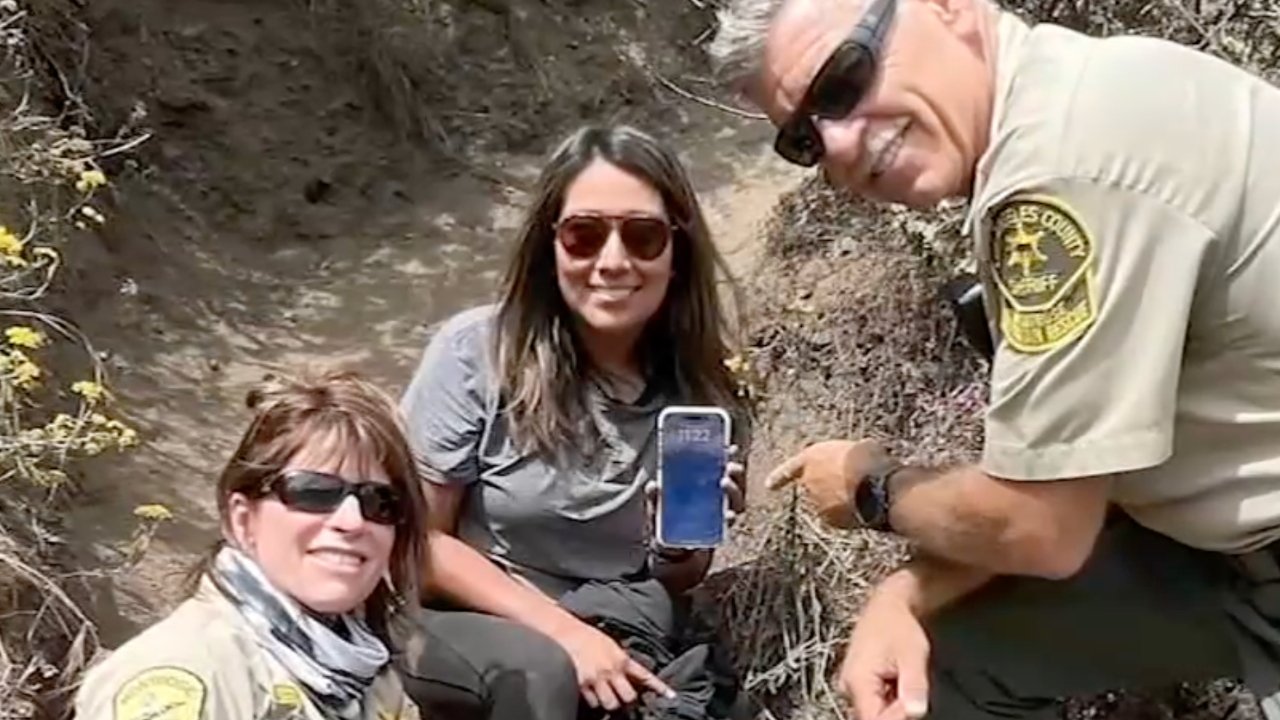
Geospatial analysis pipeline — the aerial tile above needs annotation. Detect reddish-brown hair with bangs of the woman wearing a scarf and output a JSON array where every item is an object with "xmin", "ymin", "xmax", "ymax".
[{"xmin": 188, "ymin": 368, "xmax": 426, "ymax": 639}]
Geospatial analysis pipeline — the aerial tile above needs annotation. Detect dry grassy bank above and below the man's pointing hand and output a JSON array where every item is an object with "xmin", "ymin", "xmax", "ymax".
[{"xmin": 707, "ymin": 179, "xmax": 984, "ymax": 719}]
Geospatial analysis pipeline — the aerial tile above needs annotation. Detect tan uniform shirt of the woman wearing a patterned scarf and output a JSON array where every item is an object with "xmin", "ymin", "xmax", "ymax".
[{"xmin": 76, "ymin": 579, "xmax": 419, "ymax": 720}]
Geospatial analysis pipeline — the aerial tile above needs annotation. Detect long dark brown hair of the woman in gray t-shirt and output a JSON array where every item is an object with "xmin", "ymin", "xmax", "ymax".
[{"xmin": 494, "ymin": 126, "xmax": 741, "ymax": 455}]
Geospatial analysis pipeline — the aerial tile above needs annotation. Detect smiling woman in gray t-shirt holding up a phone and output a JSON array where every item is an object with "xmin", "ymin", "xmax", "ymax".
[{"xmin": 403, "ymin": 127, "xmax": 749, "ymax": 720}]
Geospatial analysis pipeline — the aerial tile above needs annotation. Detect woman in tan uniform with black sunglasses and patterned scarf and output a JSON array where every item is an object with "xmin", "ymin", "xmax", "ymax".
[{"xmin": 76, "ymin": 372, "xmax": 426, "ymax": 720}]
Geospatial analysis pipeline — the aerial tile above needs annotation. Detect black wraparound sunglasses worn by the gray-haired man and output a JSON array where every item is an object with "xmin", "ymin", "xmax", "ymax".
[{"xmin": 773, "ymin": 0, "xmax": 897, "ymax": 168}]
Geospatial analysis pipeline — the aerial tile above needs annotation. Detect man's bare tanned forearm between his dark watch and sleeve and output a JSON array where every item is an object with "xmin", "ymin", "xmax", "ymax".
[{"xmin": 890, "ymin": 458, "xmax": 1106, "ymax": 577}]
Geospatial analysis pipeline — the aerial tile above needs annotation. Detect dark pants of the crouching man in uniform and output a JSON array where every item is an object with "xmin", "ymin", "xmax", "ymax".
[{"xmin": 927, "ymin": 515, "xmax": 1280, "ymax": 720}]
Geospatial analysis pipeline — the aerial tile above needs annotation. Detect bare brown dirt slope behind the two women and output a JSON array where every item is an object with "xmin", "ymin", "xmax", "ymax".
[{"xmin": 47, "ymin": 0, "xmax": 799, "ymax": 647}]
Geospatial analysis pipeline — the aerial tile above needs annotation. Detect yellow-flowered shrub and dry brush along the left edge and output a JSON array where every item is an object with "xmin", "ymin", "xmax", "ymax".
[{"xmin": 0, "ymin": 0, "xmax": 160, "ymax": 720}]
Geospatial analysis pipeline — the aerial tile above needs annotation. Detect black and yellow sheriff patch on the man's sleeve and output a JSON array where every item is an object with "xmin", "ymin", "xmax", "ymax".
[{"xmin": 988, "ymin": 195, "xmax": 1098, "ymax": 352}]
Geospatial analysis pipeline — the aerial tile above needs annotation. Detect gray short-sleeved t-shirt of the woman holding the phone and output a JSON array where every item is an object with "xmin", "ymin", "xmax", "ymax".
[{"xmin": 401, "ymin": 305, "xmax": 668, "ymax": 598}]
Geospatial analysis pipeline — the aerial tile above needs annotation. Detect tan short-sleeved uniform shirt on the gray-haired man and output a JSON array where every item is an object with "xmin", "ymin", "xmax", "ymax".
[{"xmin": 969, "ymin": 9, "xmax": 1280, "ymax": 551}]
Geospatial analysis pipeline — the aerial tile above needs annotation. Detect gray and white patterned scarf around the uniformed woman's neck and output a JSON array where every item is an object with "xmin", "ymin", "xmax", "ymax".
[{"xmin": 212, "ymin": 546, "xmax": 389, "ymax": 720}]
